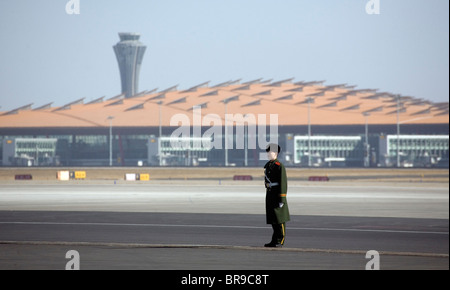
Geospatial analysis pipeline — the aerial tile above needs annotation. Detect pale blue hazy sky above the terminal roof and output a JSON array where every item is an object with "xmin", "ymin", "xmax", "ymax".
[{"xmin": 0, "ymin": 0, "xmax": 449, "ymax": 111}]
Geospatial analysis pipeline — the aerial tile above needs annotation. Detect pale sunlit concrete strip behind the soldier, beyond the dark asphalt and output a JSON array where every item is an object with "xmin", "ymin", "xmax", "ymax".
[{"xmin": 0, "ymin": 183, "xmax": 449, "ymax": 220}]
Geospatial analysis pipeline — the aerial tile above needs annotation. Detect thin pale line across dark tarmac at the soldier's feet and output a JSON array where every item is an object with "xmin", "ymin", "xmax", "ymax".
[{"xmin": 0, "ymin": 241, "xmax": 449, "ymax": 259}]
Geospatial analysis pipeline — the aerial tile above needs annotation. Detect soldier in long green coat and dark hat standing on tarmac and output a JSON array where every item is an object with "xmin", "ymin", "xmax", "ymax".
[{"xmin": 264, "ymin": 144, "xmax": 290, "ymax": 248}]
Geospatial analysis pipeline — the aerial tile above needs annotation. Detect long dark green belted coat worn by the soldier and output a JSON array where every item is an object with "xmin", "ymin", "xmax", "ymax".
[{"xmin": 264, "ymin": 159, "xmax": 290, "ymax": 224}]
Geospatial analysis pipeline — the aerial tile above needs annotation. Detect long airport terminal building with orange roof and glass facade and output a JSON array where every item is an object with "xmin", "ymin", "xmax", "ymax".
[{"xmin": 0, "ymin": 79, "xmax": 449, "ymax": 168}]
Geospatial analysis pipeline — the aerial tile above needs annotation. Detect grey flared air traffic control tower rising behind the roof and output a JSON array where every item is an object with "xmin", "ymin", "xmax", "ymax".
[{"xmin": 114, "ymin": 33, "xmax": 147, "ymax": 98}]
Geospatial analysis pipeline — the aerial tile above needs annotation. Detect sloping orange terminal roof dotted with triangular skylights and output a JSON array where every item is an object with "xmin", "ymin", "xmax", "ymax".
[{"xmin": 0, "ymin": 79, "xmax": 449, "ymax": 128}]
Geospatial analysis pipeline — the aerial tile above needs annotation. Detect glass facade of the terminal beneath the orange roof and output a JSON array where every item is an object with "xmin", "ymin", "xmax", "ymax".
[{"xmin": 0, "ymin": 133, "xmax": 449, "ymax": 168}]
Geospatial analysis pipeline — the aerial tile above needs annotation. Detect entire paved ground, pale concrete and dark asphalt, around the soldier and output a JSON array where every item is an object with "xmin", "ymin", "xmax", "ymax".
[{"xmin": 0, "ymin": 183, "xmax": 449, "ymax": 270}]
